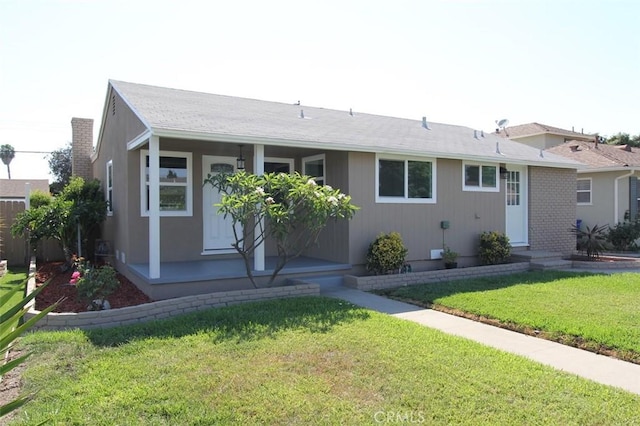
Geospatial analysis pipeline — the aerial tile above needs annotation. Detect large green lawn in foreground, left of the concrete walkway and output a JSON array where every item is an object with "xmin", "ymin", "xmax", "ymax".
[{"xmin": 8, "ymin": 297, "xmax": 640, "ymax": 425}]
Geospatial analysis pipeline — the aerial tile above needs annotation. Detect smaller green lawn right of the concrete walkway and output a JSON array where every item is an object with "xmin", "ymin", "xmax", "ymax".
[{"xmin": 378, "ymin": 271, "xmax": 640, "ymax": 361}]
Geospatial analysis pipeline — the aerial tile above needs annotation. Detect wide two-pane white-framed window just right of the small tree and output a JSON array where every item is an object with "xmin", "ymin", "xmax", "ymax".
[{"xmin": 376, "ymin": 157, "xmax": 436, "ymax": 203}]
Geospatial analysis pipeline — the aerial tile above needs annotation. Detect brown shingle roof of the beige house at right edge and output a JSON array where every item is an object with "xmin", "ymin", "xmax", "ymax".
[{"xmin": 546, "ymin": 141, "xmax": 640, "ymax": 170}]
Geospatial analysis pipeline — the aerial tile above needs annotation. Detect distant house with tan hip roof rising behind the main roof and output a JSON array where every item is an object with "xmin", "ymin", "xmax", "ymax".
[{"xmin": 496, "ymin": 123, "xmax": 594, "ymax": 149}]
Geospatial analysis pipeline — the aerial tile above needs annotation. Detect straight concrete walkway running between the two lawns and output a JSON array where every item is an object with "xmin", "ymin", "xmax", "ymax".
[{"xmin": 313, "ymin": 277, "xmax": 640, "ymax": 395}]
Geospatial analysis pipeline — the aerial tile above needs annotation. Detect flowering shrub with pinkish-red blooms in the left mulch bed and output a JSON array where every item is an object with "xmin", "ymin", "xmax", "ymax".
[{"xmin": 69, "ymin": 258, "xmax": 120, "ymax": 311}]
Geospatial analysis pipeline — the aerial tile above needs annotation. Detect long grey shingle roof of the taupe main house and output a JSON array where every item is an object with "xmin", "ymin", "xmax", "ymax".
[{"xmin": 110, "ymin": 80, "xmax": 576, "ymax": 168}]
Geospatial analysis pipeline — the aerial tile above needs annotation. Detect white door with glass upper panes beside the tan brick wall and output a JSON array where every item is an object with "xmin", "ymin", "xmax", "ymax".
[{"xmin": 506, "ymin": 164, "xmax": 529, "ymax": 246}]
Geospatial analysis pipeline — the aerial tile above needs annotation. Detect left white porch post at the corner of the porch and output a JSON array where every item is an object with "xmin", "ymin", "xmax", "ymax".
[{"xmin": 149, "ymin": 136, "xmax": 160, "ymax": 279}]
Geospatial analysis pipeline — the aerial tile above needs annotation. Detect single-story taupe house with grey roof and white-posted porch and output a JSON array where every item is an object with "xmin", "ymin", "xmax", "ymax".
[{"xmin": 82, "ymin": 81, "xmax": 578, "ymax": 299}]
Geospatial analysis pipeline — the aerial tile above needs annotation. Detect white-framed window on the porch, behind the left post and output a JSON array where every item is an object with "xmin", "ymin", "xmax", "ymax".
[{"xmin": 140, "ymin": 150, "xmax": 192, "ymax": 216}]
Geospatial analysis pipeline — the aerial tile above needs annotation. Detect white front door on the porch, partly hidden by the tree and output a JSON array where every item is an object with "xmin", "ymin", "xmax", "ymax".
[{"xmin": 202, "ymin": 155, "xmax": 236, "ymax": 253}]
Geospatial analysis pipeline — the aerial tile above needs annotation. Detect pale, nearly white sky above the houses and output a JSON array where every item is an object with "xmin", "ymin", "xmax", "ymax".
[{"xmin": 0, "ymin": 0, "xmax": 640, "ymax": 178}]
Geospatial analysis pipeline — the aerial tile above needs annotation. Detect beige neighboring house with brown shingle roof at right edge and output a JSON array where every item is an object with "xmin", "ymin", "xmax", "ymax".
[{"xmin": 546, "ymin": 139, "xmax": 640, "ymax": 230}]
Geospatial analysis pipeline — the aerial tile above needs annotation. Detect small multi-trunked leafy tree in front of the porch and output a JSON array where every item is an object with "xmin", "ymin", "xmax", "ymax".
[{"xmin": 205, "ymin": 171, "xmax": 357, "ymax": 288}]
